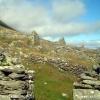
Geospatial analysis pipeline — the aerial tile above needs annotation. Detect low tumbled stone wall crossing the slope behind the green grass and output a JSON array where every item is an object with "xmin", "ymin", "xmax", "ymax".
[{"xmin": 29, "ymin": 56, "xmax": 86, "ymax": 76}]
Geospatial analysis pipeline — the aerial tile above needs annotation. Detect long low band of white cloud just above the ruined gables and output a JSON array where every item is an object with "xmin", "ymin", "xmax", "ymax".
[{"xmin": 34, "ymin": 22, "xmax": 100, "ymax": 37}]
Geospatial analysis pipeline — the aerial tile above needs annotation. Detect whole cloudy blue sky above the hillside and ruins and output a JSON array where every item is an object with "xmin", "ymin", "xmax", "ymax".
[{"xmin": 0, "ymin": 0, "xmax": 100, "ymax": 46}]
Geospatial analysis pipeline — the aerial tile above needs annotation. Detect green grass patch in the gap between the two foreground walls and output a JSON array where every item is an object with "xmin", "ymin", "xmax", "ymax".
[{"xmin": 22, "ymin": 60, "xmax": 75, "ymax": 100}]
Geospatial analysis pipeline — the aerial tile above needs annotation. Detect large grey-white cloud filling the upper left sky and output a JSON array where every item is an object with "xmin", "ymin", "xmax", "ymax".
[{"xmin": 0, "ymin": 0, "xmax": 48, "ymax": 31}]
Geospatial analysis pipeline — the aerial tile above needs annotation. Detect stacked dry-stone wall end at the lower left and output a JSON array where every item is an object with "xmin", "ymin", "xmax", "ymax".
[{"xmin": 0, "ymin": 53, "xmax": 35, "ymax": 100}]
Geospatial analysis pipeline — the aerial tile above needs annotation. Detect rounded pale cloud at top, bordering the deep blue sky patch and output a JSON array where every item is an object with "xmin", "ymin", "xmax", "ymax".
[{"xmin": 53, "ymin": 0, "xmax": 86, "ymax": 22}]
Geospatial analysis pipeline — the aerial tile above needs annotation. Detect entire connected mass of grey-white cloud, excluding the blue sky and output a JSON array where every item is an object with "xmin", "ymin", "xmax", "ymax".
[{"xmin": 0, "ymin": 0, "xmax": 100, "ymax": 38}]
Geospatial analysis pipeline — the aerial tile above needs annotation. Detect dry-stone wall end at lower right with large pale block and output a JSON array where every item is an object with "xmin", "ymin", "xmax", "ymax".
[{"xmin": 73, "ymin": 64, "xmax": 100, "ymax": 100}]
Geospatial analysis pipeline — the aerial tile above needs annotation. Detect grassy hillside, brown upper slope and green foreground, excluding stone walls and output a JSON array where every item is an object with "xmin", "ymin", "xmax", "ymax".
[{"xmin": 0, "ymin": 25, "xmax": 98, "ymax": 100}]
